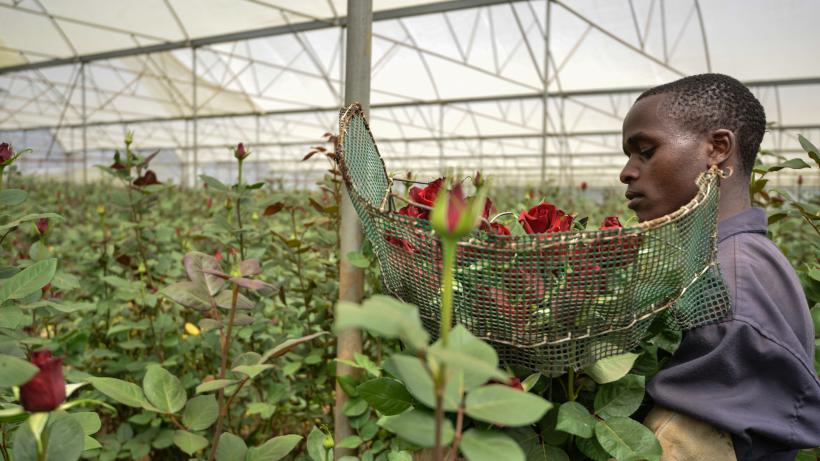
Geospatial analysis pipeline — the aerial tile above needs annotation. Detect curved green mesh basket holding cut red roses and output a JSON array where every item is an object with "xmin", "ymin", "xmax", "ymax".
[{"xmin": 337, "ymin": 104, "xmax": 730, "ymax": 375}]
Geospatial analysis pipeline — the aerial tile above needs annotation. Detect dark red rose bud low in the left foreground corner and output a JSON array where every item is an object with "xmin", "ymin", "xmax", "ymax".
[{"xmin": 20, "ymin": 350, "xmax": 65, "ymax": 412}]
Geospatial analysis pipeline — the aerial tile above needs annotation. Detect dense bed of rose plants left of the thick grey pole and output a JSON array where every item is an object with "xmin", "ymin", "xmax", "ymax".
[{"xmin": 0, "ymin": 136, "xmax": 336, "ymax": 461}]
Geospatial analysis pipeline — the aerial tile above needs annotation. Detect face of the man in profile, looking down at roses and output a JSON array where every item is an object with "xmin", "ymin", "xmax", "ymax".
[{"xmin": 620, "ymin": 95, "xmax": 709, "ymax": 221}]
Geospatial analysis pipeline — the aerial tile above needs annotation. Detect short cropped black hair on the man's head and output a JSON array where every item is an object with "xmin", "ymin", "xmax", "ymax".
[{"xmin": 636, "ymin": 74, "xmax": 766, "ymax": 174}]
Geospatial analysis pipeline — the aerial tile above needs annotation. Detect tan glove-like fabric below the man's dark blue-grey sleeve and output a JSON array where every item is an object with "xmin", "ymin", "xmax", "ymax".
[{"xmin": 644, "ymin": 406, "xmax": 737, "ymax": 461}]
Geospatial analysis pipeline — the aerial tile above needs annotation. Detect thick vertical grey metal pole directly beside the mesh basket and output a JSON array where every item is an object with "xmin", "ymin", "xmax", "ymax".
[{"xmin": 333, "ymin": 0, "xmax": 373, "ymax": 460}]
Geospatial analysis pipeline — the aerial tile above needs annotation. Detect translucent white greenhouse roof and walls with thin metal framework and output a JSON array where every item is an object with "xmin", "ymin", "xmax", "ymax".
[{"xmin": 0, "ymin": 0, "xmax": 820, "ymax": 185}]
